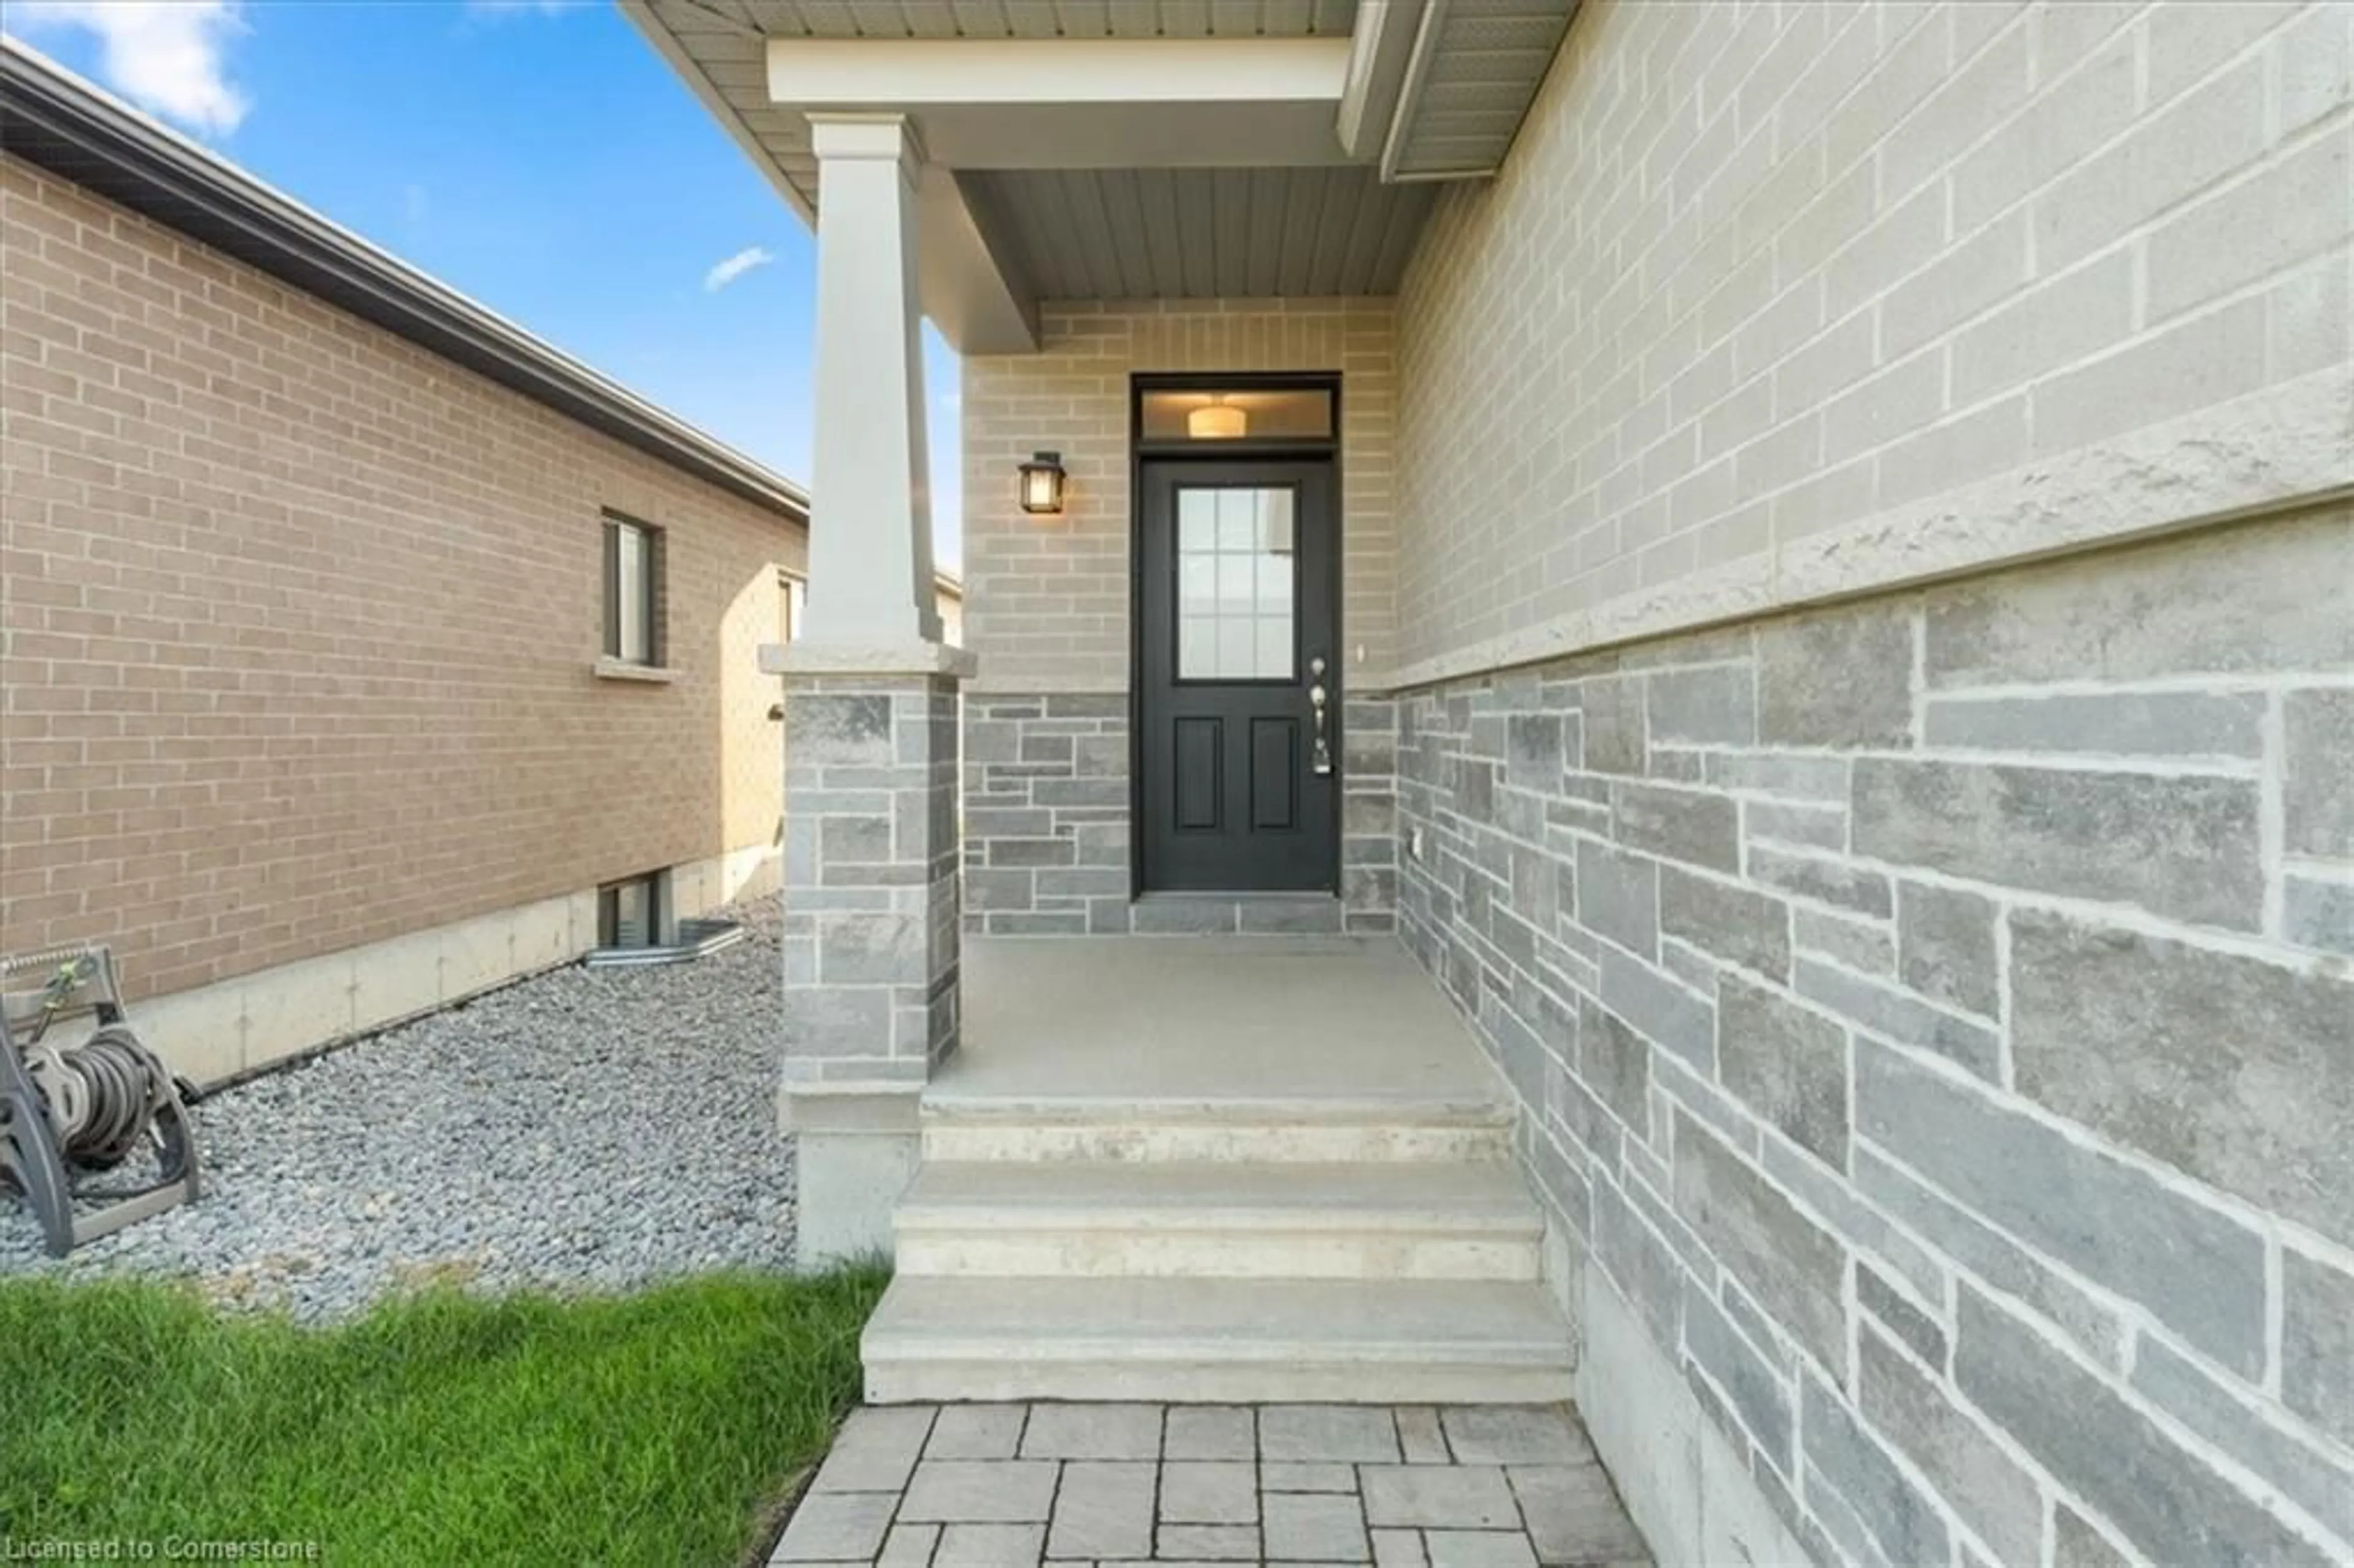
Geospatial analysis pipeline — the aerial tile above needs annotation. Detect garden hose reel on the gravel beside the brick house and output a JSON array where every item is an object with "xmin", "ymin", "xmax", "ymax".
[{"xmin": 0, "ymin": 946, "xmax": 200, "ymax": 1257}]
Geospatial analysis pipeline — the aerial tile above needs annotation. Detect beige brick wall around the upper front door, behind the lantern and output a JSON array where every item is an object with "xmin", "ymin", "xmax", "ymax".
[{"xmin": 963, "ymin": 299, "xmax": 1398, "ymax": 692}]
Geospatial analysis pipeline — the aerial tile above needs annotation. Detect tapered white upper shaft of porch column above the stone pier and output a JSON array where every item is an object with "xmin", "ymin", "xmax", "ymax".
[{"xmin": 807, "ymin": 115, "xmax": 939, "ymax": 647}]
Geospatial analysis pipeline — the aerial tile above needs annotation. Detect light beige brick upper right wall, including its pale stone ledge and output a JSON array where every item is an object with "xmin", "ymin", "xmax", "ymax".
[{"xmin": 1398, "ymin": 0, "xmax": 2354, "ymax": 678}]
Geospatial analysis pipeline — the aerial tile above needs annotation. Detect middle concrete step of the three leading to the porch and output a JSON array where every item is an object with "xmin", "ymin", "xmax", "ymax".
[{"xmin": 892, "ymin": 1161, "xmax": 1544, "ymax": 1281}]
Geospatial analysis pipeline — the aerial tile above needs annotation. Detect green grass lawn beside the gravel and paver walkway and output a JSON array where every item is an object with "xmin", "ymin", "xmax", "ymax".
[{"xmin": 0, "ymin": 1271, "xmax": 883, "ymax": 1568}]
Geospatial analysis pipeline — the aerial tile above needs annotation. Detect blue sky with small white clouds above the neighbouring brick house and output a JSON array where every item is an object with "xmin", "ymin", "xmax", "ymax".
[{"xmin": 0, "ymin": 0, "xmax": 961, "ymax": 563}]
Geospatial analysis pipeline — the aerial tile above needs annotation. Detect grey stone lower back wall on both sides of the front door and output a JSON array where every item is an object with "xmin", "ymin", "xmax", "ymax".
[{"xmin": 965, "ymin": 692, "xmax": 1398, "ymax": 937}]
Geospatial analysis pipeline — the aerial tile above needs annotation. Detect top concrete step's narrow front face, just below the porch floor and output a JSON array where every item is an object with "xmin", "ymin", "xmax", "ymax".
[{"xmin": 923, "ymin": 1095, "xmax": 1511, "ymax": 1165}]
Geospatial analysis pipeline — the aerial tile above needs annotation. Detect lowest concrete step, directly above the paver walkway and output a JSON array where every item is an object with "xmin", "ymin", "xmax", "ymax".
[{"xmin": 859, "ymin": 1274, "xmax": 1575, "ymax": 1403}]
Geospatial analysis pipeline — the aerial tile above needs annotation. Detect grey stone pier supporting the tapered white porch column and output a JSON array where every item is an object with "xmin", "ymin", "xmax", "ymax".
[{"xmin": 784, "ymin": 676, "xmax": 958, "ymax": 1095}]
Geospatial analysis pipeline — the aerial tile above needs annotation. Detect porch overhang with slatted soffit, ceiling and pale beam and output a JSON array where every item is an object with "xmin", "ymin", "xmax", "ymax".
[{"xmin": 624, "ymin": 0, "xmax": 1575, "ymax": 353}]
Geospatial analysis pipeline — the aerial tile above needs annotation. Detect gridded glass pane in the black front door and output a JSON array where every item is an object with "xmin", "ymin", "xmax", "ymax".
[{"xmin": 1177, "ymin": 485, "xmax": 1300, "ymax": 680}]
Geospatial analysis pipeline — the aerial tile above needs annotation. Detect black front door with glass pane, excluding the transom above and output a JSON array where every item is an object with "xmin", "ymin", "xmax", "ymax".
[{"xmin": 1137, "ymin": 457, "xmax": 1339, "ymax": 892}]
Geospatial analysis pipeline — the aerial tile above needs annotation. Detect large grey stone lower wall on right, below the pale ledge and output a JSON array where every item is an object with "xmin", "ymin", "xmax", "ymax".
[{"xmin": 1398, "ymin": 509, "xmax": 2354, "ymax": 1568}]
